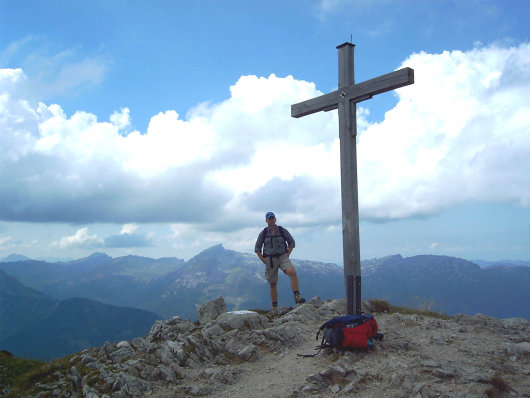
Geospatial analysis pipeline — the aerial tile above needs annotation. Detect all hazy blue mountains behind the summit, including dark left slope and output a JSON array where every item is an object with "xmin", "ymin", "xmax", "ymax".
[{"xmin": 0, "ymin": 245, "xmax": 530, "ymax": 359}]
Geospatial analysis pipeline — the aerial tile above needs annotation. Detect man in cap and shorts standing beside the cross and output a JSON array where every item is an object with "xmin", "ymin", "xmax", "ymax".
[{"xmin": 254, "ymin": 211, "xmax": 305, "ymax": 309}]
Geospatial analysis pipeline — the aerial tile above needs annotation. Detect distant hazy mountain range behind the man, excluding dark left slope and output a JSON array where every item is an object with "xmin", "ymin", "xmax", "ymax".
[{"xmin": 0, "ymin": 245, "xmax": 530, "ymax": 319}]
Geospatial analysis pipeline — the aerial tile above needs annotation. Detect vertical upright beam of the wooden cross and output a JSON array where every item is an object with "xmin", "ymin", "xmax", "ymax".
[{"xmin": 337, "ymin": 43, "xmax": 361, "ymax": 314}]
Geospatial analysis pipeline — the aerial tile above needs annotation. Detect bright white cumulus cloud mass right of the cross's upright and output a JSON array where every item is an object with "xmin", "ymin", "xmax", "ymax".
[{"xmin": 359, "ymin": 43, "xmax": 530, "ymax": 219}]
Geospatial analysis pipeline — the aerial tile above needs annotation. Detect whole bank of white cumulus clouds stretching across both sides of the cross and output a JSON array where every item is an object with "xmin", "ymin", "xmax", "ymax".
[{"xmin": 0, "ymin": 43, "xmax": 530, "ymax": 233}]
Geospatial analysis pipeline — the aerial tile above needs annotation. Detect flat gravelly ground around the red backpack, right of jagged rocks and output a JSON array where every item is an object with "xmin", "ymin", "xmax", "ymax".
[{"xmin": 208, "ymin": 314, "xmax": 530, "ymax": 398}]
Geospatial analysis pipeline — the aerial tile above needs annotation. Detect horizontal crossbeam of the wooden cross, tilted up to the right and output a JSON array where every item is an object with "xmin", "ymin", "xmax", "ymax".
[{"xmin": 291, "ymin": 68, "xmax": 414, "ymax": 118}]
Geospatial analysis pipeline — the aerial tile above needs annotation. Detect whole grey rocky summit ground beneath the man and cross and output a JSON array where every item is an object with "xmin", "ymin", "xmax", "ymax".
[{"xmin": 6, "ymin": 297, "xmax": 530, "ymax": 398}]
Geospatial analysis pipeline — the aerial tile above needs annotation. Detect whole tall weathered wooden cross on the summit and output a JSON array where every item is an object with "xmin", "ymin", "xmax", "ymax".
[{"xmin": 291, "ymin": 43, "xmax": 414, "ymax": 314}]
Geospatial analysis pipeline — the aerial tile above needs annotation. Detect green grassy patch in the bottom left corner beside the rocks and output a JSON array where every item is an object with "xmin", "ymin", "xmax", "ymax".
[{"xmin": 0, "ymin": 351, "xmax": 92, "ymax": 398}]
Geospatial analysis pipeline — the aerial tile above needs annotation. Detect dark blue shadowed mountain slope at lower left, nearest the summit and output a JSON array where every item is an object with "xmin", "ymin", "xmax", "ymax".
[{"xmin": 0, "ymin": 270, "xmax": 160, "ymax": 360}]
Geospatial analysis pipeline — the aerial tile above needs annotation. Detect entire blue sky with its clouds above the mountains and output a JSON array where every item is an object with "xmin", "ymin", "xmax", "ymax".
[{"xmin": 0, "ymin": 0, "xmax": 530, "ymax": 263}]
